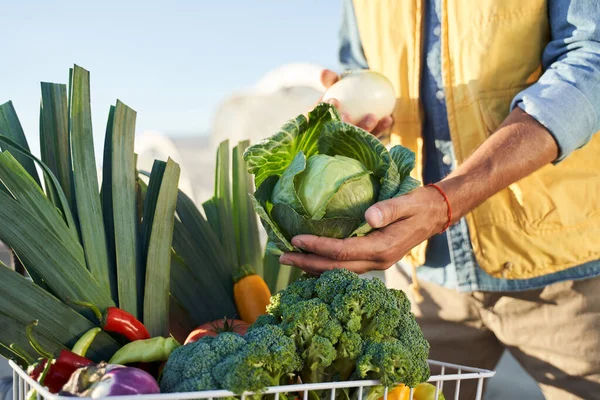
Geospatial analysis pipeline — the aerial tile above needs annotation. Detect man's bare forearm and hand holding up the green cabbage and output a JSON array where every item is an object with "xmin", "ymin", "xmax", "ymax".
[{"xmin": 280, "ymin": 108, "xmax": 558, "ymax": 274}]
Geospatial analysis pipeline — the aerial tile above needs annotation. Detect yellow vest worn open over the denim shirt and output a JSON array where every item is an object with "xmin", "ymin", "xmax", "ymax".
[{"xmin": 354, "ymin": 0, "xmax": 600, "ymax": 279}]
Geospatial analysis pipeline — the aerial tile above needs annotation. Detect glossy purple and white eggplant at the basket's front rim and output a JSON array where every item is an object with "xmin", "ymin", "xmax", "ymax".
[{"xmin": 59, "ymin": 362, "xmax": 160, "ymax": 399}]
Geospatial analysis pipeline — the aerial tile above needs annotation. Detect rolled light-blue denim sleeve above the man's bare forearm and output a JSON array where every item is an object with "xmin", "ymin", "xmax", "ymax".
[{"xmin": 511, "ymin": 0, "xmax": 600, "ymax": 163}]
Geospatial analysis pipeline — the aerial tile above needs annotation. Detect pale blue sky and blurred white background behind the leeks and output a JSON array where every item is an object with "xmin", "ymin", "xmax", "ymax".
[{"xmin": 0, "ymin": 0, "xmax": 543, "ymax": 400}]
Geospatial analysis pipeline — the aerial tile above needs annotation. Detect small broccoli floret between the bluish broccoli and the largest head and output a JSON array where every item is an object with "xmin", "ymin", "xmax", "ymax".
[{"xmin": 213, "ymin": 325, "xmax": 302, "ymax": 394}]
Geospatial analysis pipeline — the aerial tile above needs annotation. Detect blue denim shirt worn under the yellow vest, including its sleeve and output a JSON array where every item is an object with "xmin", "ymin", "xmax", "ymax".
[{"xmin": 339, "ymin": 0, "xmax": 600, "ymax": 292}]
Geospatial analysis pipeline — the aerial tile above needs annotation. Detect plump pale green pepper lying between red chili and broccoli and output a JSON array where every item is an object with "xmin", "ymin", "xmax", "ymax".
[{"xmin": 108, "ymin": 336, "xmax": 181, "ymax": 365}]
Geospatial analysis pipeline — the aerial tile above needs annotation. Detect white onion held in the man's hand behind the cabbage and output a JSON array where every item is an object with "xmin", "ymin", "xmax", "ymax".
[{"xmin": 323, "ymin": 70, "xmax": 396, "ymax": 124}]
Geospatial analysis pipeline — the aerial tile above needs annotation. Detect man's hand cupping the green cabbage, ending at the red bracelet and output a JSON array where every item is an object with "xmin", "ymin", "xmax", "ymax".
[{"xmin": 280, "ymin": 188, "xmax": 448, "ymax": 274}]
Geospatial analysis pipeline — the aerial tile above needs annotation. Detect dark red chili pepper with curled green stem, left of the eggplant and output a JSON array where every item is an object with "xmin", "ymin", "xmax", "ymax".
[{"xmin": 27, "ymin": 320, "xmax": 93, "ymax": 393}]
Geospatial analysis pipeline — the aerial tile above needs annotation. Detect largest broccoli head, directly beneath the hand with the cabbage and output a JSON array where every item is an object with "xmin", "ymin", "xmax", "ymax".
[{"xmin": 255, "ymin": 269, "xmax": 429, "ymax": 390}]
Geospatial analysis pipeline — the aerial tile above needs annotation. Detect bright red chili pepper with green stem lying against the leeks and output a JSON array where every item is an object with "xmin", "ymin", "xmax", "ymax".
[{"xmin": 69, "ymin": 300, "xmax": 150, "ymax": 342}]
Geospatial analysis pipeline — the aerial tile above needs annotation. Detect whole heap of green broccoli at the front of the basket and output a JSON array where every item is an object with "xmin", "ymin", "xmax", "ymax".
[{"xmin": 160, "ymin": 269, "xmax": 429, "ymax": 399}]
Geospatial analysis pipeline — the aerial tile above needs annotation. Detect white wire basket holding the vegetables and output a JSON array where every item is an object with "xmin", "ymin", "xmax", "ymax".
[{"xmin": 9, "ymin": 360, "xmax": 496, "ymax": 400}]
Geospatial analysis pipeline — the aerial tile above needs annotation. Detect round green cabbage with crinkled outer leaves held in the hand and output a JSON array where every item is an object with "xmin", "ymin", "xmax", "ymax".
[{"xmin": 244, "ymin": 103, "xmax": 419, "ymax": 254}]
